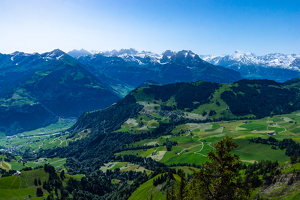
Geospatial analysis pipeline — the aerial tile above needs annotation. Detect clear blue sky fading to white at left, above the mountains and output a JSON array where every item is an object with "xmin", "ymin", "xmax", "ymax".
[{"xmin": 0, "ymin": 0, "xmax": 300, "ymax": 55}]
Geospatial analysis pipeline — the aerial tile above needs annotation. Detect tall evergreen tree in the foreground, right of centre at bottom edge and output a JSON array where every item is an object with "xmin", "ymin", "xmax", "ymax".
[{"xmin": 167, "ymin": 137, "xmax": 253, "ymax": 200}]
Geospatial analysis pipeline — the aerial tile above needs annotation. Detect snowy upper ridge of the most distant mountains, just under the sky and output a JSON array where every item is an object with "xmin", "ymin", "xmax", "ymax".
[{"xmin": 68, "ymin": 48, "xmax": 300, "ymax": 71}]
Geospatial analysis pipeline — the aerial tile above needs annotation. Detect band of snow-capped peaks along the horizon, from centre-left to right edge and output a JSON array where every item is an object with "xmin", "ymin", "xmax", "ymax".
[{"xmin": 69, "ymin": 48, "xmax": 300, "ymax": 71}]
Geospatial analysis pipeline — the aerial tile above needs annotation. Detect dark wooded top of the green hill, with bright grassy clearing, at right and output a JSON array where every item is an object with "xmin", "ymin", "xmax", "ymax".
[{"xmin": 132, "ymin": 79, "xmax": 300, "ymax": 119}]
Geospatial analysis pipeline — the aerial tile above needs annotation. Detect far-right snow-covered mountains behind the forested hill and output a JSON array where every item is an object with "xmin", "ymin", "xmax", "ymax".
[{"xmin": 200, "ymin": 51, "xmax": 300, "ymax": 82}]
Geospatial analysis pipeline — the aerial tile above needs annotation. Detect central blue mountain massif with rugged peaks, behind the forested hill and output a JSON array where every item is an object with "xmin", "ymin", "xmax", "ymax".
[{"xmin": 71, "ymin": 49, "xmax": 241, "ymax": 88}]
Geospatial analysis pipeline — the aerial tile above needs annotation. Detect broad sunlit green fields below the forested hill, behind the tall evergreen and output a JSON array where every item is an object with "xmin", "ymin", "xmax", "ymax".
[{"xmin": 115, "ymin": 112, "xmax": 300, "ymax": 164}]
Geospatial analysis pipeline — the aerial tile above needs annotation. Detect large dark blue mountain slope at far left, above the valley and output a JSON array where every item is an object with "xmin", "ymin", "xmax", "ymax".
[{"xmin": 0, "ymin": 50, "xmax": 119, "ymax": 135}]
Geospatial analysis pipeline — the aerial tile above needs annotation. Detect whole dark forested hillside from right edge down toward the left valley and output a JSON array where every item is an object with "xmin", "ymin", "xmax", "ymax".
[{"xmin": 41, "ymin": 80, "xmax": 299, "ymax": 173}]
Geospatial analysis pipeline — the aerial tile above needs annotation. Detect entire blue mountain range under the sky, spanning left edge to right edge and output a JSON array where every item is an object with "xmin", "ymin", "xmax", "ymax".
[{"xmin": 0, "ymin": 48, "xmax": 300, "ymax": 135}]
